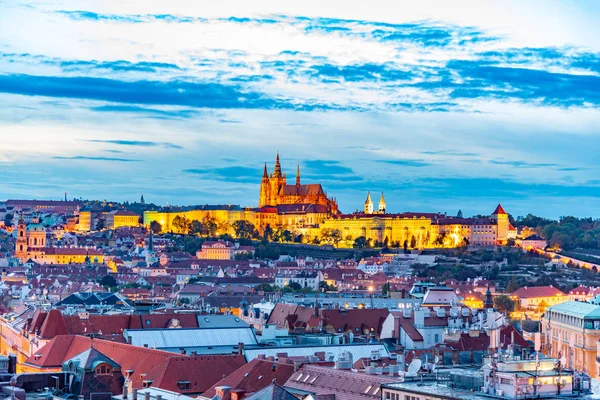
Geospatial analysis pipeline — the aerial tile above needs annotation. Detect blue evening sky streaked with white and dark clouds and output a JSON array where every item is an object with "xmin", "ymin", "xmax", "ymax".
[{"xmin": 0, "ymin": 0, "xmax": 600, "ymax": 218}]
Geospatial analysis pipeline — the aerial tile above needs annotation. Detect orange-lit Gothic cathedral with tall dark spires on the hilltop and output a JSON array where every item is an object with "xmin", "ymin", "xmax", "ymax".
[{"xmin": 258, "ymin": 153, "xmax": 338, "ymax": 214}]
